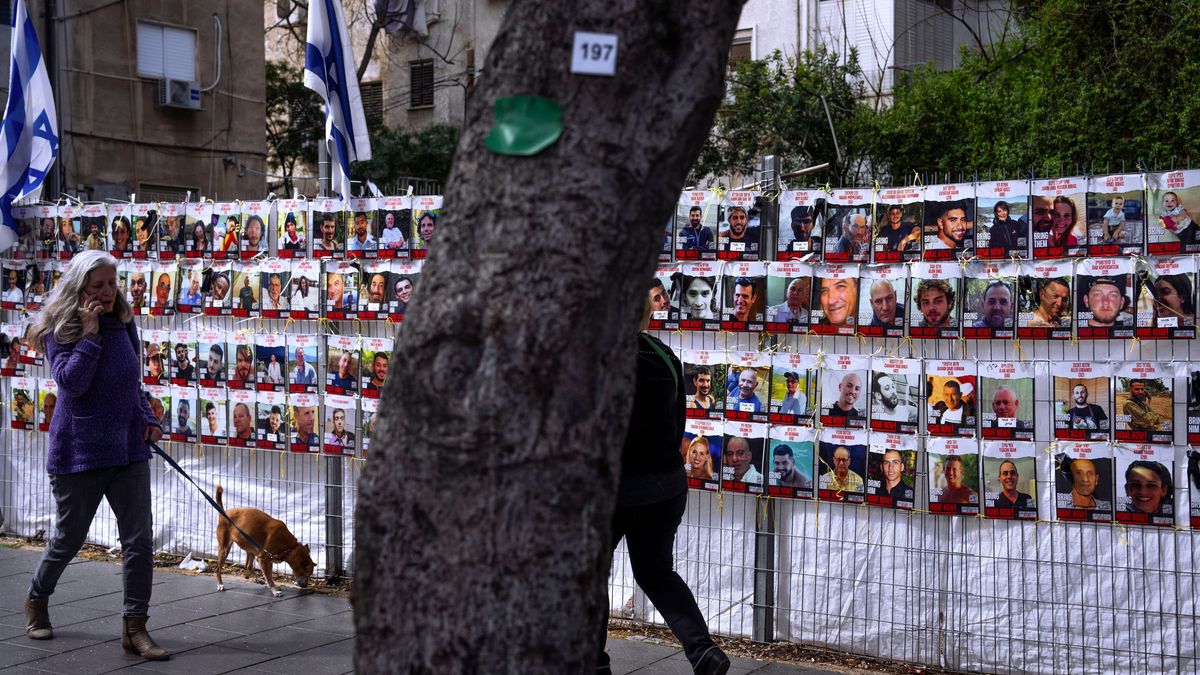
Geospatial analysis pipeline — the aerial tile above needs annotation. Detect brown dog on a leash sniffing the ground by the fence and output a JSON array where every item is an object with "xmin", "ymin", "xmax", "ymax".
[{"xmin": 217, "ymin": 485, "xmax": 317, "ymax": 597}]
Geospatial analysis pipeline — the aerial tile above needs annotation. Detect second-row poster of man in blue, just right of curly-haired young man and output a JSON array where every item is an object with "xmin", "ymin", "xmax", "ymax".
[{"xmin": 962, "ymin": 261, "xmax": 1020, "ymax": 340}]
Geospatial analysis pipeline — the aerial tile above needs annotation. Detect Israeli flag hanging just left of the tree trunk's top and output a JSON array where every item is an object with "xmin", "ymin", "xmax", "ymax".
[{"xmin": 304, "ymin": 0, "xmax": 371, "ymax": 199}]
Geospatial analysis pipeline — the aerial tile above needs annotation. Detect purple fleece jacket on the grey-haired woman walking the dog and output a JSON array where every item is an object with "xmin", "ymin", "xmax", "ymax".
[{"xmin": 46, "ymin": 315, "xmax": 158, "ymax": 474}]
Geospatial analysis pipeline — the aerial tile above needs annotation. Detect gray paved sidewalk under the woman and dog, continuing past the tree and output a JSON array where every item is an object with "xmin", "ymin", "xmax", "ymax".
[{"xmin": 0, "ymin": 546, "xmax": 845, "ymax": 675}]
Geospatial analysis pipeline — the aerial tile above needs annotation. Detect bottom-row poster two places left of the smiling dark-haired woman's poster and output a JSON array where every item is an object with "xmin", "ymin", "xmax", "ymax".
[{"xmin": 983, "ymin": 441, "xmax": 1038, "ymax": 520}]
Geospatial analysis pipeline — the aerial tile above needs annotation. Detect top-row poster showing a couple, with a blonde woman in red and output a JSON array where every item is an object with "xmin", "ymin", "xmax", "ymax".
[{"xmin": 1030, "ymin": 177, "xmax": 1087, "ymax": 259}]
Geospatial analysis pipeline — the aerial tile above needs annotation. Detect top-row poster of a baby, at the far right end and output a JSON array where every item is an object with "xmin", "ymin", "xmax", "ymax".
[{"xmin": 1145, "ymin": 169, "xmax": 1200, "ymax": 254}]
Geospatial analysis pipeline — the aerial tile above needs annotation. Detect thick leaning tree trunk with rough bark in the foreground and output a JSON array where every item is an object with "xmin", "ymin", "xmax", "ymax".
[{"xmin": 354, "ymin": 0, "xmax": 742, "ymax": 675}]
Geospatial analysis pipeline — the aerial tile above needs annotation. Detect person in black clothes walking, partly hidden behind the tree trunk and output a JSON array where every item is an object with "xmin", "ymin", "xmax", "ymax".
[{"xmin": 596, "ymin": 288, "xmax": 730, "ymax": 675}]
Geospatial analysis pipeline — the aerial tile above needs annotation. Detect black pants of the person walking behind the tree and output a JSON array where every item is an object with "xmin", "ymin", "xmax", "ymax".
[{"xmin": 598, "ymin": 492, "xmax": 715, "ymax": 669}]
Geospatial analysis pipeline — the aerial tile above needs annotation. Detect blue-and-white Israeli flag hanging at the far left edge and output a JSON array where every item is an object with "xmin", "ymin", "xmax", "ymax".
[{"xmin": 0, "ymin": 0, "xmax": 59, "ymax": 251}]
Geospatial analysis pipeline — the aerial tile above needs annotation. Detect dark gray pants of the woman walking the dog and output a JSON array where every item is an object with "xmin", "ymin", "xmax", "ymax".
[{"xmin": 29, "ymin": 460, "xmax": 154, "ymax": 616}]
